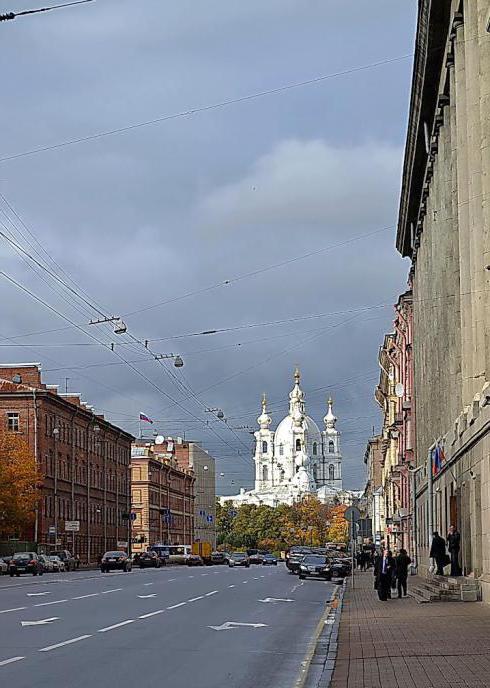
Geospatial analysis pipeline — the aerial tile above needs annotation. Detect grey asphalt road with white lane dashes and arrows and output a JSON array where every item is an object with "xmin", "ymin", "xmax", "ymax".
[{"xmin": 0, "ymin": 565, "xmax": 334, "ymax": 688}]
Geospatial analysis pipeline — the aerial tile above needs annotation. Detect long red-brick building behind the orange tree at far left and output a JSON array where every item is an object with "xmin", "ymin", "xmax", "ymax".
[{"xmin": 0, "ymin": 363, "xmax": 133, "ymax": 562}]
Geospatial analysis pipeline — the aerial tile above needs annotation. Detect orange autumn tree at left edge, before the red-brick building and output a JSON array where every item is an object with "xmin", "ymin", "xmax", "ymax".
[{"xmin": 0, "ymin": 431, "xmax": 42, "ymax": 537}]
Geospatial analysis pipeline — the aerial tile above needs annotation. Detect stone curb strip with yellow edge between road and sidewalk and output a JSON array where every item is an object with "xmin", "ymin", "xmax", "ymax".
[{"xmin": 295, "ymin": 578, "xmax": 347, "ymax": 688}]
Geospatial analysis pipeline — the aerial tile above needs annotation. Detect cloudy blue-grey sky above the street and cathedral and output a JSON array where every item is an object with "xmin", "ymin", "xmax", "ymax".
[{"xmin": 0, "ymin": 0, "xmax": 417, "ymax": 494}]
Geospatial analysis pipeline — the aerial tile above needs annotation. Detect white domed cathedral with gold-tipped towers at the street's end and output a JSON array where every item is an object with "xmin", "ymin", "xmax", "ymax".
[{"xmin": 220, "ymin": 369, "xmax": 342, "ymax": 506}]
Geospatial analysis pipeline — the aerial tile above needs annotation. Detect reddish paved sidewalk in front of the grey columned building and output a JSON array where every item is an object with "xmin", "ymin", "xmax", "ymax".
[{"xmin": 330, "ymin": 571, "xmax": 490, "ymax": 688}]
